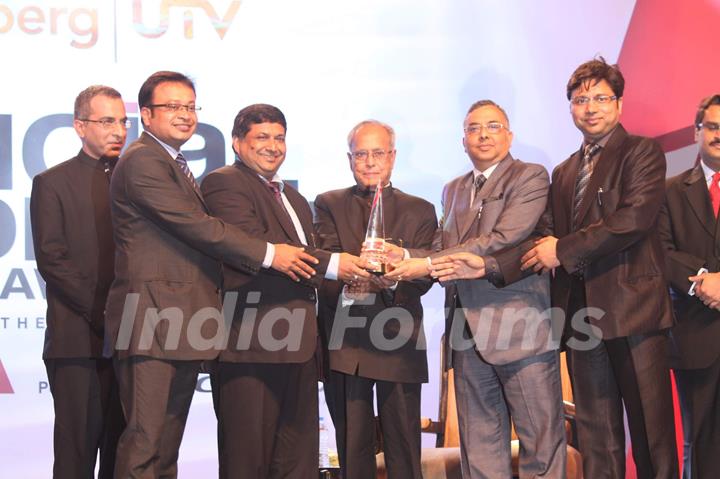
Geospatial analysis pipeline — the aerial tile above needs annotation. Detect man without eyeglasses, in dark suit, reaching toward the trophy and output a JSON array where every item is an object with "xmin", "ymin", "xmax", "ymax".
[{"xmin": 202, "ymin": 104, "xmax": 369, "ymax": 479}]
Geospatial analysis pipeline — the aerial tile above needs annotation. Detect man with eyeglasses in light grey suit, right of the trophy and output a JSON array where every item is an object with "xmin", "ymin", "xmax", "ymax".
[{"xmin": 386, "ymin": 100, "xmax": 567, "ymax": 479}]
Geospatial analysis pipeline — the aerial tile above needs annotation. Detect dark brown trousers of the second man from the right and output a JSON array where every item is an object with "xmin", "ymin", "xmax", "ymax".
[{"xmin": 567, "ymin": 281, "xmax": 678, "ymax": 479}]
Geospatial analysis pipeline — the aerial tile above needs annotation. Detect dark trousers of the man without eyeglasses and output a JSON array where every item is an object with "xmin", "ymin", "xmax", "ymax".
[{"xmin": 215, "ymin": 358, "xmax": 319, "ymax": 479}]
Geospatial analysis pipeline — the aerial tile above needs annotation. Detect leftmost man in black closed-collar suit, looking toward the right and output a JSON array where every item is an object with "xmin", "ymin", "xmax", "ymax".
[{"xmin": 30, "ymin": 85, "xmax": 127, "ymax": 479}]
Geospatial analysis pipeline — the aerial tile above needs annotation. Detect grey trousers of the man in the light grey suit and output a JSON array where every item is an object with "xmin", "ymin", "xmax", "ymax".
[{"xmin": 453, "ymin": 348, "xmax": 567, "ymax": 479}]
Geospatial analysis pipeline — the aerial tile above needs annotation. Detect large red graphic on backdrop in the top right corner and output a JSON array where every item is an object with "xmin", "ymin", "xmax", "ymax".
[{"xmin": 618, "ymin": 0, "xmax": 720, "ymax": 151}]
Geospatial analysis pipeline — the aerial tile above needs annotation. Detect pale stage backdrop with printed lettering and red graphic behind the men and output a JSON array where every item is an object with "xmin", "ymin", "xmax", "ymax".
[{"xmin": 0, "ymin": 0, "xmax": 708, "ymax": 478}]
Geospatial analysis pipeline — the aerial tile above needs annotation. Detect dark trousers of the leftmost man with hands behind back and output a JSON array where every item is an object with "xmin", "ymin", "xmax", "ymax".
[{"xmin": 45, "ymin": 358, "xmax": 125, "ymax": 479}]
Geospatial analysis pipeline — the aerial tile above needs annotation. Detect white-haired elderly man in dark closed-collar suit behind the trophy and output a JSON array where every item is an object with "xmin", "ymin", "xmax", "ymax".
[{"xmin": 315, "ymin": 120, "xmax": 437, "ymax": 479}]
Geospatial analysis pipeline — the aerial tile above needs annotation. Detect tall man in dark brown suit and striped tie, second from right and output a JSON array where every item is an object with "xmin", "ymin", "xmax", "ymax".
[{"xmin": 484, "ymin": 58, "xmax": 678, "ymax": 479}]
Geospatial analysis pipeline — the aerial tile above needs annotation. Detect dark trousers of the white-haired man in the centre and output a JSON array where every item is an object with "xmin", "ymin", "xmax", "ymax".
[{"xmin": 325, "ymin": 371, "xmax": 422, "ymax": 479}]
